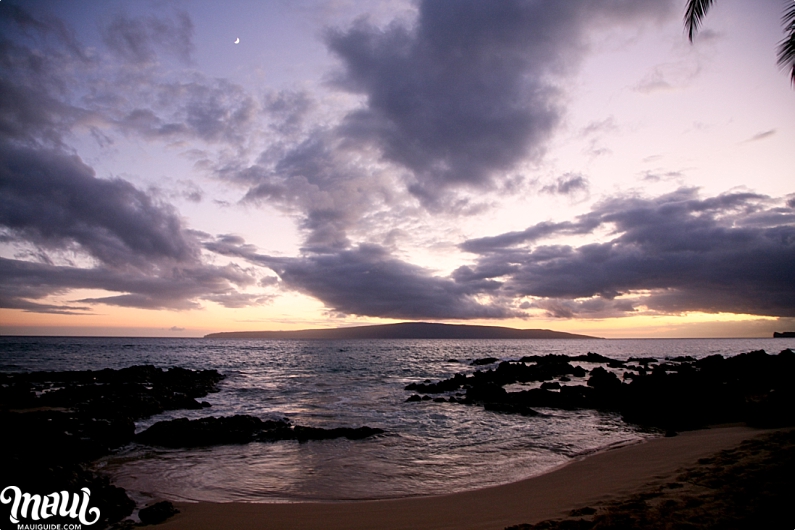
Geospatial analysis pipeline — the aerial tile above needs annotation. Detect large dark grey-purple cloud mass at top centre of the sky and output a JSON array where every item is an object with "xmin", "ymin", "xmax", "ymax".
[{"xmin": 221, "ymin": 0, "xmax": 672, "ymax": 252}]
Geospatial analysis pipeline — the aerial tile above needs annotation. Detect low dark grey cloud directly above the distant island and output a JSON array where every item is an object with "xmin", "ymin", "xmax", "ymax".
[{"xmin": 206, "ymin": 236, "xmax": 519, "ymax": 319}]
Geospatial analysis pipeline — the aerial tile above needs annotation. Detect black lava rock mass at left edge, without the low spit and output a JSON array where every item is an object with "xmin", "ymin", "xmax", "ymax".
[{"xmin": 0, "ymin": 366, "xmax": 223, "ymax": 528}]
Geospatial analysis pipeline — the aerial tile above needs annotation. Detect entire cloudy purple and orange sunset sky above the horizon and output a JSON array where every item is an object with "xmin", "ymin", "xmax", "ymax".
[{"xmin": 0, "ymin": 0, "xmax": 795, "ymax": 338}]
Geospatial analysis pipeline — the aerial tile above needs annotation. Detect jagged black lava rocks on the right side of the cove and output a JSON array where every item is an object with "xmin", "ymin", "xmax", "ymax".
[{"xmin": 406, "ymin": 350, "xmax": 795, "ymax": 432}]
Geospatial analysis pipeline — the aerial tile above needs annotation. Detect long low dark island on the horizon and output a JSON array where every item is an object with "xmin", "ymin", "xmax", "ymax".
[{"xmin": 204, "ymin": 322, "xmax": 601, "ymax": 340}]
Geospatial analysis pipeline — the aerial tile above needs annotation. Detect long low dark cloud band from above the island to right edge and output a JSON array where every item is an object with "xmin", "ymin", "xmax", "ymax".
[{"xmin": 215, "ymin": 189, "xmax": 795, "ymax": 319}]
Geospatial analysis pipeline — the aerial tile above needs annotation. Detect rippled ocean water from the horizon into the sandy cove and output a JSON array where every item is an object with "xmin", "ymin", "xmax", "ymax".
[{"xmin": 0, "ymin": 337, "xmax": 795, "ymax": 502}]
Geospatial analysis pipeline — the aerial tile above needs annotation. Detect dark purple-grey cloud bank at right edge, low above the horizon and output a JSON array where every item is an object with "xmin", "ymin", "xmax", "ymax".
[{"xmin": 456, "ymin": 189, "xmax": 795, "ymax": 316}]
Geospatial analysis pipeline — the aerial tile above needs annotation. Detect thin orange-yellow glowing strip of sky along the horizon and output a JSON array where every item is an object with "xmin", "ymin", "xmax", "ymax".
[{"xmin": 0, "ymin": 295, "xmax": 795, "ymax": 338}]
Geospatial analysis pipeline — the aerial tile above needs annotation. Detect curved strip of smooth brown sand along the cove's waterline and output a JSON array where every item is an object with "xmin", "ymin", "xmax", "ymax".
[{"xmin": 160, "ymin": 426, "xmax": 770, "ymax": 530}]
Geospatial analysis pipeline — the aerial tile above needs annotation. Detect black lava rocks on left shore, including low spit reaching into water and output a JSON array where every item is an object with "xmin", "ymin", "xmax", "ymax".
[{"xmin": 0, "ymin": 366, "xmax": 383, "ymax": 529}]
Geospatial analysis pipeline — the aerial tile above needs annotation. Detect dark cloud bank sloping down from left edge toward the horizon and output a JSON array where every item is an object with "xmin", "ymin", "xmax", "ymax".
[{"xmin": 0, "ymin": 144, "xmax": 262, "ymax": 314}]
